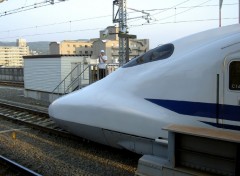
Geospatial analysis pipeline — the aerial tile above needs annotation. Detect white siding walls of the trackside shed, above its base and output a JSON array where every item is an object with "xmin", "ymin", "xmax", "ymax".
[{"xmin": 24, "ymin": 55, "xmax": 84, "ymax": 93}]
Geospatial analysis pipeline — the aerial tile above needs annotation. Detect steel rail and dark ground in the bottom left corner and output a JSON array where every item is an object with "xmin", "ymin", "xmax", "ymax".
[{"xmin": 0, "ymin": 155, "xmax": 41, "ymax": 176}]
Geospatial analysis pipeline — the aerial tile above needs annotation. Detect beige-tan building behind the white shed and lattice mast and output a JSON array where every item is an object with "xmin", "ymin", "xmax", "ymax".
[{"xmin": 49, "ymin": 26, "xmax": 149, "ymax": 63}]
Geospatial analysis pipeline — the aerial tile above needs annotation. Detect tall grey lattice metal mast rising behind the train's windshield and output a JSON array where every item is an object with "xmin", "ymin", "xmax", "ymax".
[{"xmin": 113, "ymin": 0, "xmax": 128, "ymax": 66}]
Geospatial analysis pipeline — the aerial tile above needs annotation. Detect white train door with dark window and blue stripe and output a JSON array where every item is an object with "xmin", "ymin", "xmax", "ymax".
[{"xmin": 220, "ymin": 53, "xmax": 240, "ymax": 130}]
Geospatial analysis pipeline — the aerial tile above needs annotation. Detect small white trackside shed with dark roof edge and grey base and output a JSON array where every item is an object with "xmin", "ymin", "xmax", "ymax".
[{"xmin": 24, "ymin": 55, "xmax": 90, "ymax": 102}]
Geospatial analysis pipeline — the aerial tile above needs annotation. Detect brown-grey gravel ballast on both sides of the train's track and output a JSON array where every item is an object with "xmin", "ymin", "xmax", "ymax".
[{"xmin": 0, "ymin": 87, "xmax": 141, "ymax": 176}]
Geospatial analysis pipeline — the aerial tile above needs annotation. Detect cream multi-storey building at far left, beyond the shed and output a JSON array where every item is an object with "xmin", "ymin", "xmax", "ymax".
[{"xmin": 0, "ymin": 39, "xmax": 29, "ymax": 67}]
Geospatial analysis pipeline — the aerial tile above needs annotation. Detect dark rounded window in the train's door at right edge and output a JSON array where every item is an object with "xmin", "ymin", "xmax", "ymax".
[{"xmin": 229, "ymin": 61, "xmax": 240, "ymax": 90}]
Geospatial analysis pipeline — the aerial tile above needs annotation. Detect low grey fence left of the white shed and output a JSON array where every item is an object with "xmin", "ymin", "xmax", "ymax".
[{"xmin": 0, "ymin": 68, "xmax": 24, "ymax": 83}]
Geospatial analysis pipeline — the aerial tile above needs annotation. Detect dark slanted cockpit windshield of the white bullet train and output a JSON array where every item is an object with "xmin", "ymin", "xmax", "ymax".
[{"xmin": 123, "ymin": 43, "xmax": 174, "ymax": 68}]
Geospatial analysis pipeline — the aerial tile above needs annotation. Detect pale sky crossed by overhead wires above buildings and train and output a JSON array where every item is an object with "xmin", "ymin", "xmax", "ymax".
[{"xmin": 0, "ymin": 0, "xmax": 239, "ymax": 48}]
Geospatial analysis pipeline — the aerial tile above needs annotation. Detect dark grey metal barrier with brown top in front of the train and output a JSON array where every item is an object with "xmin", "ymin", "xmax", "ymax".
[{"xmin": 135, "ymin": 125, "xmax": 240, "ymax": 176}]
